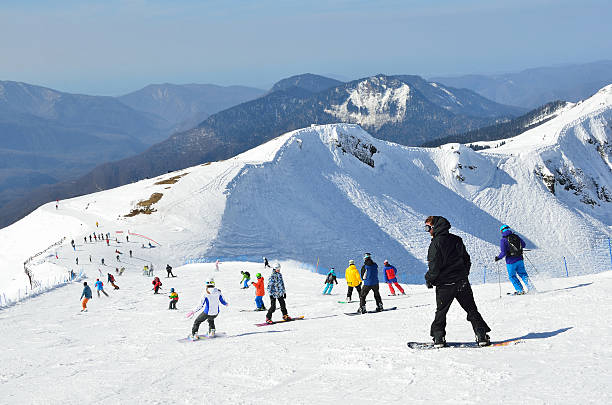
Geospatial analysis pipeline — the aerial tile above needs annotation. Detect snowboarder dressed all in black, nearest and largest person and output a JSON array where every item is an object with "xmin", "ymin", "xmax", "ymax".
[{"xmin": 425, "ymin": 216, "xmax": 491, "ymax": 347}]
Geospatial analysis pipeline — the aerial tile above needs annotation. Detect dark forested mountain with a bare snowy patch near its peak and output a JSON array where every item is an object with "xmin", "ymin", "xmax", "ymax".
[{"xmin": 0, "ymin": 74, "xmax": 525, "ymax": 225}]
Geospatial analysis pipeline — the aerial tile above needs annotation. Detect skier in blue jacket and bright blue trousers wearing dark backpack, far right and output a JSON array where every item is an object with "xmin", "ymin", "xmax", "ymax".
[{"xmin": 495, "ymin": 225, "xmax": 536, "ymax": 295}]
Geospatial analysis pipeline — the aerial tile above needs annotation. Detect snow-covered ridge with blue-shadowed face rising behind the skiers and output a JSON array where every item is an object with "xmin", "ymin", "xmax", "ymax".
[{"xmin": 0, "ymin": 86, "xmax": 612, "ymax": 300}]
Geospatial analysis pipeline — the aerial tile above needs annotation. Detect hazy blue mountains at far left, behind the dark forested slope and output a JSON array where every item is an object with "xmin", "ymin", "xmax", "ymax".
[{"xmin": 0, "ymin": 81, "xmax": 265, "ymax": 221}]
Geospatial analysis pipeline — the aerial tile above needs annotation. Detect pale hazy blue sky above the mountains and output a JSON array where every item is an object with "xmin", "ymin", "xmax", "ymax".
[{"xmin": 0, "ymin": 0, "xmax": 612, "ymax": 95}]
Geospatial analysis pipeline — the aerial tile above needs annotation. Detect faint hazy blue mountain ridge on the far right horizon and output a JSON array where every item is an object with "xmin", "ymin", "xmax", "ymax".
[{"xmin": 431, "ymin": 60, "xmax": 612, "ymax": 109}]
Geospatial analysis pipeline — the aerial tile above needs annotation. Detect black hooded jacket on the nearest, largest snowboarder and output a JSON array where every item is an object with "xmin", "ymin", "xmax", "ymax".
[{"xmin": 425, "ymin": 217, "xmax": 472, "ymax": 286}]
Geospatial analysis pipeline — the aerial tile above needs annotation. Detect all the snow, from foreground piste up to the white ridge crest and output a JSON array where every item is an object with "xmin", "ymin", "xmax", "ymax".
[{"xmin": 0, "ymin": 86, "xmax": 612, "ymax": 404}]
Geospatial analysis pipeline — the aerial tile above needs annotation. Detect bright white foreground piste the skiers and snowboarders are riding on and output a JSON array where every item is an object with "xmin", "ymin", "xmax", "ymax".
[{"xmin": 0, "ymin": 254, "xmax": 612, "ymax": 404}]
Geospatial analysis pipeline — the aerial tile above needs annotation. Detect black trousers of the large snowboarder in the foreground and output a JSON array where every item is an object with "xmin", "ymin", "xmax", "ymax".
[{"xmin": 430, "ymin": 280, "xmax": 491, "ymax": 338}]
